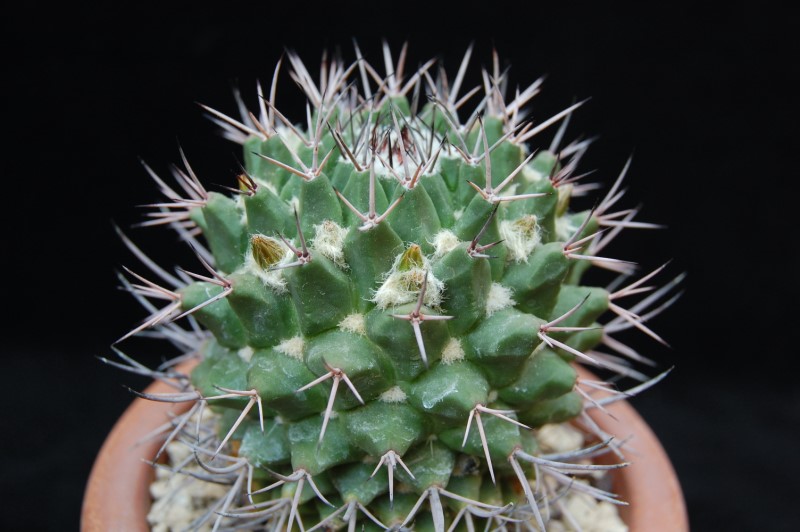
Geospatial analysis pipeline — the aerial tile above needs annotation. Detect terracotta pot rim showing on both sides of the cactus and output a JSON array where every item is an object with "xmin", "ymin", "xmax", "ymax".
[{"xmin": 81, "ymin": 368, "xmax": 689, "ymax": 532}]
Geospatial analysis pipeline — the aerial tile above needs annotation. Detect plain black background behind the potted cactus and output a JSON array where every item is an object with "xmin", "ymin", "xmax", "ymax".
[{"xmin": 0, "ymin": 1, "xmax": 800, "ymax": 530}]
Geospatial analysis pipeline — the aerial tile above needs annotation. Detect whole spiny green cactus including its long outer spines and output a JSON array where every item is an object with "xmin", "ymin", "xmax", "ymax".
[{"xmin": 108, "ymin": 46, "xmax": 680, "ymax": 531}]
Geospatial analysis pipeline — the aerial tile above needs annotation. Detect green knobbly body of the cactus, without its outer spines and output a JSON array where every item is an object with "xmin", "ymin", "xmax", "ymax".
[{"xmin": 122, "ymin": 45, "xmax": 680, "ymax": 530}]
